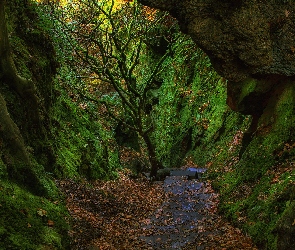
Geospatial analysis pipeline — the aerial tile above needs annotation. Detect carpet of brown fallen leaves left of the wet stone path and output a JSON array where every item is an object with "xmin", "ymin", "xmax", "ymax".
[{"xmin": 58, "ymin": 171, "xmax": 164, "ymax": 250}]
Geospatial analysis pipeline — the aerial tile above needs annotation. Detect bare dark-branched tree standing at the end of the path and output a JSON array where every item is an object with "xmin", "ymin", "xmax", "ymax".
[{"xmin": 57, "ymin": 0, "xmax": 177, "ymax": 176}]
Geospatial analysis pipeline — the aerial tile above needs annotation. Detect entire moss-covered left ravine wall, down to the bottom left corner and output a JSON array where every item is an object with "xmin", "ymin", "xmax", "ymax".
[{"xmin": 0, "ymin": 0, "xmax": 120, "ymax": 250}]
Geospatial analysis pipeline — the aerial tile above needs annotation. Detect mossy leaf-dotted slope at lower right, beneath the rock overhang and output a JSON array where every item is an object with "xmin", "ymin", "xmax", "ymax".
[{"xmin": 208, "ymin": 83, "xmax": 295, "ymax": 249}]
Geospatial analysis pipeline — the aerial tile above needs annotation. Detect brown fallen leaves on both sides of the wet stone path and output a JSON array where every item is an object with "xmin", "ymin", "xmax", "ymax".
[{"xmin": 57, "ymin": 171, "xmax": 257, "ymax": 250}]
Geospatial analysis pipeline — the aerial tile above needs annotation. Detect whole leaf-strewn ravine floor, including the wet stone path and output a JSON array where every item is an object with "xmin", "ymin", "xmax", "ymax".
[{"xmin": 58, "ymin": 169, "xmax": 257, "ymax": 250}]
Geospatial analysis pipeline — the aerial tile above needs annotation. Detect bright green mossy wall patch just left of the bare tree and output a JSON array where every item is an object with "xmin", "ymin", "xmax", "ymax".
[{"xmin": 50, "ymin": 74, "xmax": 121, "ymax": 179}]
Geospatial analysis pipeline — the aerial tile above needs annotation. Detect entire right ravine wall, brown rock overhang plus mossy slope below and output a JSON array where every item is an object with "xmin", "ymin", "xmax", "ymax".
[{"xmin": 140, "ymin": 0, "xmax": 295, "ymax": 249}]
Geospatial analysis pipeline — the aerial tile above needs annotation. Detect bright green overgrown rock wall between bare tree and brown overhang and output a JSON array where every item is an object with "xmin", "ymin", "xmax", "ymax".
[{"xmin": 153, "ymin": 45, "xmax": 250, "ymax": 167}]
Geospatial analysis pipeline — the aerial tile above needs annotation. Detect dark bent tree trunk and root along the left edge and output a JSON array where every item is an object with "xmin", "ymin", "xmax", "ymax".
[{"xmin": 0, "ymin": 0, "xmax": 44, "ymax": 194}]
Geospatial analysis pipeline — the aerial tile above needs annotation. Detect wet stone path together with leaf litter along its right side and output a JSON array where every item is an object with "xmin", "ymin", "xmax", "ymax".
[{"xmin": 140, "ymin": 169, "xmax": 256, "ymax": 250}]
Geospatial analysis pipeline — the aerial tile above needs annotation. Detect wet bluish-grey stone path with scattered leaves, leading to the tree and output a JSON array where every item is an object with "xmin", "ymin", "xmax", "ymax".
[{"xmin": 140, "ymin": 176, "xmax": 212, "ymax": 249}]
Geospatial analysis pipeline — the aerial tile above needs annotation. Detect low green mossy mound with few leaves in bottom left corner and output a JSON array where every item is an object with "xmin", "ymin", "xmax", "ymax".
[{"xmin": 0, "ymin": 181, "xmax": 69, "ymax": 250}]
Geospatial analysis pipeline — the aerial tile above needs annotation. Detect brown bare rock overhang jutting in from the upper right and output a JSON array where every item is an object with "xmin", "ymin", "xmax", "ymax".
[{"xmin": 140, "ymin": 0, "xmax": 295, "ymax": 115}]
